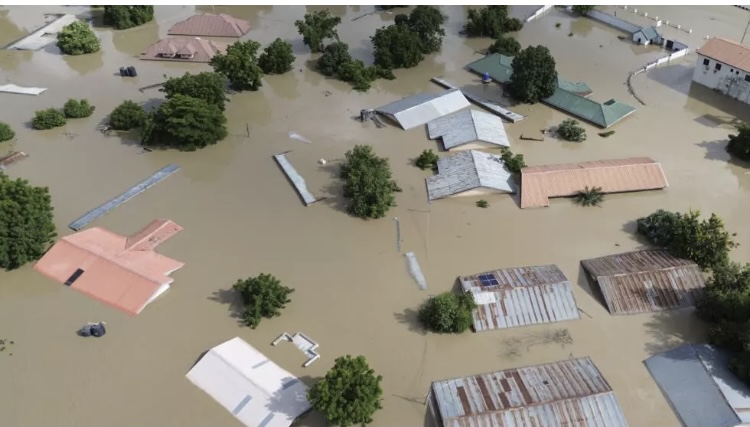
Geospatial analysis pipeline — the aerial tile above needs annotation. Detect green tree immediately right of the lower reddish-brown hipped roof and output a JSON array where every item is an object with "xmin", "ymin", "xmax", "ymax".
[{"xmin": 211, "ymin": 40, "xmax": 263, "ymax": 90}]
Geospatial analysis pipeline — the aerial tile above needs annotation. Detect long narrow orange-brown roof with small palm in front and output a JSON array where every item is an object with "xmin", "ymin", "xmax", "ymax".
[{"xmin": 521, "ymin": 157, "xmax": 669, "ymax": 209}]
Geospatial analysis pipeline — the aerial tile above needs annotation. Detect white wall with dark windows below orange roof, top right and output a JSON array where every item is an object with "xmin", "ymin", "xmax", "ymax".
[{"xmin": 693, "ymin": 54, "xmax": 750, "ymax": 104}]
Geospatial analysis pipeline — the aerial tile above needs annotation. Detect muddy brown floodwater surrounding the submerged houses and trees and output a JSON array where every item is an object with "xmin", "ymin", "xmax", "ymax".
[{"xmin": 0, "ymin": 6, "xmax": 750, "ymax": 427}]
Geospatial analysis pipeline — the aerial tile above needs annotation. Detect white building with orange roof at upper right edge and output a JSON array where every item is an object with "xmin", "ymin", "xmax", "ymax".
[{"xmin": 693, "ymin": 37, "xmax": 750, "ymax": 104}]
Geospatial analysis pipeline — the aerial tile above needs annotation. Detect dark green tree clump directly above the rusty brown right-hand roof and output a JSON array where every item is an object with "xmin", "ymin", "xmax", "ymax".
[{"xmin": 637, "ymin": 209, "xmax": 737, "ymax": 270}]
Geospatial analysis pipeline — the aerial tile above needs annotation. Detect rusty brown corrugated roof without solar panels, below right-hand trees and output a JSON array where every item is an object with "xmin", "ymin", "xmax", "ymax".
[{"xmin": 581, "ymin": 250, "xmax": 706, "ymax": 314}]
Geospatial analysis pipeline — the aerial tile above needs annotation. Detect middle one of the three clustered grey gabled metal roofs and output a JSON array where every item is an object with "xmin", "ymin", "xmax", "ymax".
[{"xmin": 427, "ymin": 109, "xmax": 510, "ymax": 150}]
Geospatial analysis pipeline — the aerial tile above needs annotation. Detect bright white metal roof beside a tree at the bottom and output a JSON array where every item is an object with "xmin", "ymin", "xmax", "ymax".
[{"xmin": 186, "ymin": 338, "xmax": 310, "ymax": 427}]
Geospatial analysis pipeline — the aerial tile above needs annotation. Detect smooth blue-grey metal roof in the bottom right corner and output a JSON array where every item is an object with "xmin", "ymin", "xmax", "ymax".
[{"xmin": 644, "ymin": 344, "xmax": 750, "ymax": 427}]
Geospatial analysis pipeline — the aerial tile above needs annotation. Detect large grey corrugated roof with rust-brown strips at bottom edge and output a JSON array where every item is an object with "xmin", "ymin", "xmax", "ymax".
[{"xmin": 430, "ymin": 357, "xmax": 627, "ymax": 427}]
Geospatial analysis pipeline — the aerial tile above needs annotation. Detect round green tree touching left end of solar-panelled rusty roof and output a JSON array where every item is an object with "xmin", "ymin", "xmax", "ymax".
[{"xmin": 417, "ymin": 292, "xmax": 476, "ymax": 334}]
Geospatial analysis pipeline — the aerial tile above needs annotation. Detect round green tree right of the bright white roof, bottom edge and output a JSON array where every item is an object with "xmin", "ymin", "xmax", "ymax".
[{"xmin": 307, "ymin": 355, "xmax": 383, "ymax": 426}]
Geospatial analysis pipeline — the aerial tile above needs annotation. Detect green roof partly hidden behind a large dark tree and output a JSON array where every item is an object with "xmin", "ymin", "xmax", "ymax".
[{"xmin": 467, "ymin": 53, "xmax": 635, "ymax": 128}]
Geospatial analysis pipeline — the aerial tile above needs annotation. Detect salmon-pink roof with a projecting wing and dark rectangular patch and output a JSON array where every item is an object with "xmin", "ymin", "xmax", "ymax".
[{"xmin": 34, "ymin": 219, "xmax": 185, "ymax": 315}]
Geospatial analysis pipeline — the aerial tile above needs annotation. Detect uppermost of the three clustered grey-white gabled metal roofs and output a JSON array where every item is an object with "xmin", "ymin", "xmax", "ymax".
[{"xmin": 375, "ymin": 89, "xmax": 470, "ymax": 130}]
